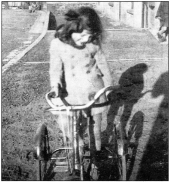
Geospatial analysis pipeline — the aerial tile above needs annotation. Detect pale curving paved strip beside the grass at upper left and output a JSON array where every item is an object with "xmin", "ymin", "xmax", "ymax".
[{"xmin": 2, "ymin": 11, "xmax": 49, "ymax": 73}]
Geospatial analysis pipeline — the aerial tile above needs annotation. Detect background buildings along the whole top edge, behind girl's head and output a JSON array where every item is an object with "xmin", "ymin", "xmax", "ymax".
[{"xmin": 2, "ymin": 1, "xmax": 166, "ymax": 30}]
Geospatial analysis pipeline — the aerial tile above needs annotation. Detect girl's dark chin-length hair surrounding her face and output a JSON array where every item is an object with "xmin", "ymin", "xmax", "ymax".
[{"xmin": 55, "ymin": 7, "xmax": 103, "ymax": 45}]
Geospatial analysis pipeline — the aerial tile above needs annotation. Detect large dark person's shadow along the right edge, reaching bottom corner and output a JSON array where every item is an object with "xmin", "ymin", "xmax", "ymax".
[{"xmin": 136, "ymin": 72, "xmax": 169, "ymax": 181}]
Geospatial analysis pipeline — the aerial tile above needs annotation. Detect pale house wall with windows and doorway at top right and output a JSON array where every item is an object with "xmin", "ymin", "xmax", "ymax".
[{"xmin": 97, "ymin": 1, "xmax": 160, "ymax": 29}]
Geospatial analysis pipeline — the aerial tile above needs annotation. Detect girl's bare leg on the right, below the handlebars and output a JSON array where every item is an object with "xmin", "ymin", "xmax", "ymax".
[{"xmin": 93, "ymin": 113, "xmax": 102, "ymax": 151}]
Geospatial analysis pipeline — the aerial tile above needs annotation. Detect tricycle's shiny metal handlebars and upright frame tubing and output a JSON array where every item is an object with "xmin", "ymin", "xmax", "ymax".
[{"xmin": 43, "ymin": 86, "xmax": 127, "ymax": 180}]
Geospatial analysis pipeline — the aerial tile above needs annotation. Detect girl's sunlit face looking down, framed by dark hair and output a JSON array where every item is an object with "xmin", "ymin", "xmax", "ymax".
[{"xmin": 71, "ymin": 30, "xmax": 92, "ymax": 46}]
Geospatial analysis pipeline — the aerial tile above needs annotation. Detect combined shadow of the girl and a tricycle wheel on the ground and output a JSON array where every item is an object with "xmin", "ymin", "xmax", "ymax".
[{"xmin": 102, "ymin": 63, "xmax": 150, "ymax": 179}]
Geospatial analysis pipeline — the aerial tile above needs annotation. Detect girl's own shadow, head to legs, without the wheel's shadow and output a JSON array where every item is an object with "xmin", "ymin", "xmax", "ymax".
[{"xmin": 102, "ymin": 63, "xmax": 149, "ymax": 145}]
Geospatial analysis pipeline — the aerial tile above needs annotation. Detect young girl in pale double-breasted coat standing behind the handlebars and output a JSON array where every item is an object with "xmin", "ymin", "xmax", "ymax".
[{"xmin": 50, "ymin": 7, "xmax": 112, "ymax": 158}]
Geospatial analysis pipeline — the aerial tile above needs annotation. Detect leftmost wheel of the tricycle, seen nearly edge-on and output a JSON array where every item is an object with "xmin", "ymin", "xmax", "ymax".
[{"xmin": 35, "ymin": 123, "xmax": 50, "ymax": 181}]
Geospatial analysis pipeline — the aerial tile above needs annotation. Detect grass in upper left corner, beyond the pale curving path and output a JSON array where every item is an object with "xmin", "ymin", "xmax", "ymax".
[{"xmin": 1, "ymin": 9, "xmax": 39, "ymax": 60}]
